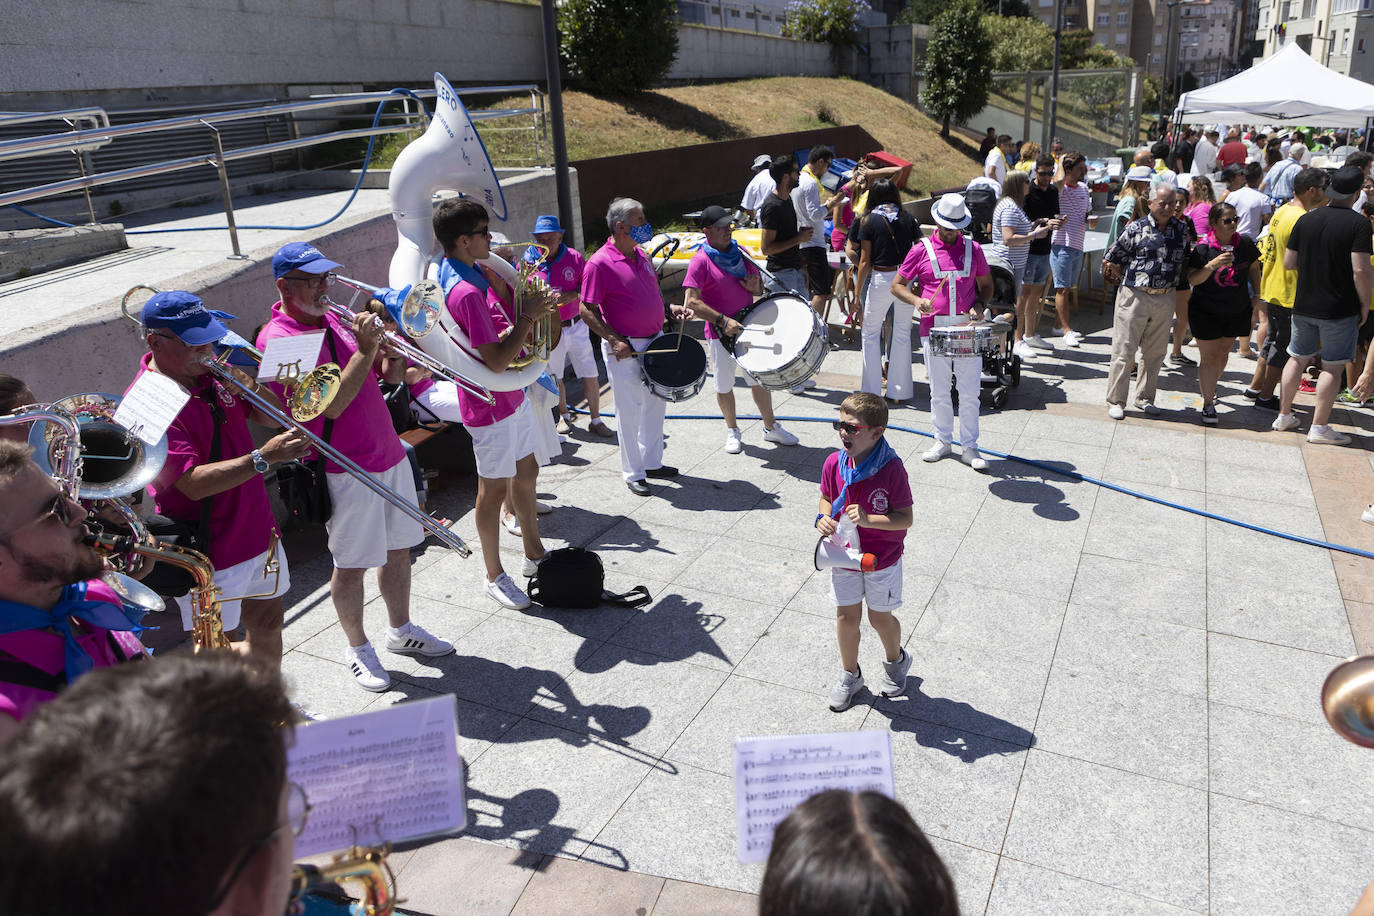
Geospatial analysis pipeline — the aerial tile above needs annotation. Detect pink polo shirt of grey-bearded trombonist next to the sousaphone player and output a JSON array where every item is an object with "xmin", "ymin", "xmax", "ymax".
[{"xmin": 257, "ymin": 302, "xmax": 405, "ymax": 474}]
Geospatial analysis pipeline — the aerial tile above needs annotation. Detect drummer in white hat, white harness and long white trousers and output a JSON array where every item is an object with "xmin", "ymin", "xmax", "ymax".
[{"xmin": 892, "ymin": 194, "xmax": 992, "ymax": 471}]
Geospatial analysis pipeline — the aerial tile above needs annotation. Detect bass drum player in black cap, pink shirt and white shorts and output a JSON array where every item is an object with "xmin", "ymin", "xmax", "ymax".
[{"xmin": 683, "ymin": 206, "xmax": 797, "ymax": 455}]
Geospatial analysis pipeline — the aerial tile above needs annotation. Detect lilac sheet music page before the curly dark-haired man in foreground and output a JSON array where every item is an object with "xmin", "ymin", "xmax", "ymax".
[{"xmin": 286, "ymin": 694, "xmax": 467, "ymax": 856}]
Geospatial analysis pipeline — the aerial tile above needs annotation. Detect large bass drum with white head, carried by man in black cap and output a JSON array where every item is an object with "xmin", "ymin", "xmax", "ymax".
[{"xmin": 724, "ymin": 293, "xmax": 830, "ymax": 391}]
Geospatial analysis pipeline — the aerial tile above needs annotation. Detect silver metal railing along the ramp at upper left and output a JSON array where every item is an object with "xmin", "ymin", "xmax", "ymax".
[{"xmin": 0, "ymin": 84, "xmax": 547, "ymax": 258}]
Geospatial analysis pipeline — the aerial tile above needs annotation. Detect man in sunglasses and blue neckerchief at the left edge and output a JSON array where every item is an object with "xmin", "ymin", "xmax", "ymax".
[{"xmin": 0, "ymin": 439, "xmax": 144, "ymax": 744}]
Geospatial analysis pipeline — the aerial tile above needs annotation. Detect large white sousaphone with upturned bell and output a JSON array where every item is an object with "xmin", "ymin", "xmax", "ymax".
[{"xmin": 389, "ymin": 73, "xmax": 558, "ymax": 391}]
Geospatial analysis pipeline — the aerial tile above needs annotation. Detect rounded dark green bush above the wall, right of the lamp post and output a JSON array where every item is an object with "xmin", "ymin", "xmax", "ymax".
[{"xmin": 558, "ymin": 0, "xmax": 677, "ymax": 95}]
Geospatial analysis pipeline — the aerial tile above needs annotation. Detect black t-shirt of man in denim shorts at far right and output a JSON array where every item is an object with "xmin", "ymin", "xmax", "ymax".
[{"xmin": 1287, "ymin": 206, "xmax": 1374, "ymax": 319}]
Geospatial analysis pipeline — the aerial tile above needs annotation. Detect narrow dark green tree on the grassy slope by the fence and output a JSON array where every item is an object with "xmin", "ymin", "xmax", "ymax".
[{"xmin": 921, "ymin": 0, "xmax": 992, "ymax": 137}]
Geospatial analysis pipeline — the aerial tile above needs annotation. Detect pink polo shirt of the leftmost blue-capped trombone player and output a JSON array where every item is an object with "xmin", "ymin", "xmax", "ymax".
[{"xmin": 129, "ymin": 353, "xmax": 276, "ymax": 570}]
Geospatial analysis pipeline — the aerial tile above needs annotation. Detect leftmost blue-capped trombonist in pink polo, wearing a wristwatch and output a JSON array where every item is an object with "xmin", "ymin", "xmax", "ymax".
[{"xmin": 129, "ymin": 290, "xmax": 309, "ymax": 667}]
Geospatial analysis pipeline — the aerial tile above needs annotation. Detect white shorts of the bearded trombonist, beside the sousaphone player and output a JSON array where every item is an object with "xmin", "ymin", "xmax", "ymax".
[{"xmin": 324, "ymin": 457, "xmax": 425, "ymax": 570}]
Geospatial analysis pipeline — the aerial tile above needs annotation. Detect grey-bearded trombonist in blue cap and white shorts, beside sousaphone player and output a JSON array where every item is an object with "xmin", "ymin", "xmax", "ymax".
[{"xmin": 257, "ymin": 242, "xmax": 453, "ymax": 692}]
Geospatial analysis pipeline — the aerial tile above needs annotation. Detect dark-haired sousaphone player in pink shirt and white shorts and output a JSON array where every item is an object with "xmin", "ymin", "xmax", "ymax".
[{"xmin": 431, "ymin": 204, "xmax": 548, "ymax": 610}]
